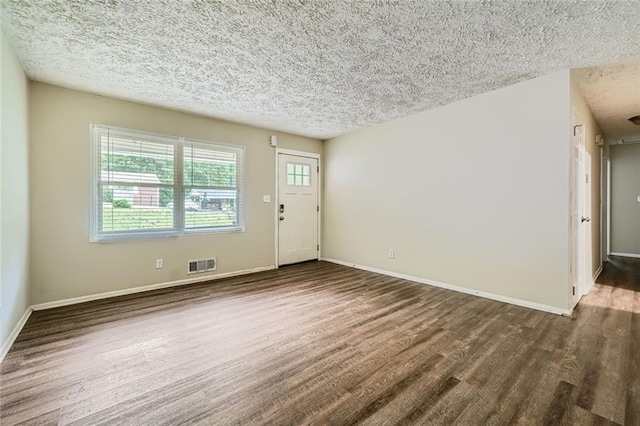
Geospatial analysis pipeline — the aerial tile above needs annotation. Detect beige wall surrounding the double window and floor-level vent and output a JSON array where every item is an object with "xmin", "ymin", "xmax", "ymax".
[{"xmin": 30, "ymin": 82, "xmax": 322, "ymax": 304}]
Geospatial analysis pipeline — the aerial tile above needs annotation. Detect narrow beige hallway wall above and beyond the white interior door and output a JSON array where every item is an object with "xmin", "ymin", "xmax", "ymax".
[{"xmin": 571, "ymin": 75, "xmax": 602, "ymax": 276}]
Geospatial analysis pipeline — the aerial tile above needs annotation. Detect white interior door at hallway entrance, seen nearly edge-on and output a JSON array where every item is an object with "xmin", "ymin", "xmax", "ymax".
[{"xmin": 571, "ymin": 125, "xmax": 591, "ymax": 307}]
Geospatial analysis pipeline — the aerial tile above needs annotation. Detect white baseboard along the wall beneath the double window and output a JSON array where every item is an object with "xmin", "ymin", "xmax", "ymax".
[{"xmin": 31, "ymin": 265, "xmax": 276, "ymax": 311}]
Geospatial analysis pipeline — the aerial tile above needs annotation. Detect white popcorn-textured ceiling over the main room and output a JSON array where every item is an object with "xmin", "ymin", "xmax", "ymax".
[{"xmin": 0, "ymin": 0, "xmax": 640, "ymax": 139}]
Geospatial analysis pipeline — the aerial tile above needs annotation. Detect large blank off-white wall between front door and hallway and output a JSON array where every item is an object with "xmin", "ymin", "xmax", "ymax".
[{"xmin": 323, "ymin": 71, "xmax": 570, "ymax": 310}]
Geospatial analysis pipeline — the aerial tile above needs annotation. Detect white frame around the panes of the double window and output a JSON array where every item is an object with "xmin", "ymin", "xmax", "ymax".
[{"xmin": 89, "ymin": 123, "xmax": 246, "ymax": 243}]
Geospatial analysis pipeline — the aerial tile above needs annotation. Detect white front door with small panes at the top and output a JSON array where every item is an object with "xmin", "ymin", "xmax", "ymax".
[{"xmin": 277, "ymin": 154, "xmax": 320, "ymax": 265}]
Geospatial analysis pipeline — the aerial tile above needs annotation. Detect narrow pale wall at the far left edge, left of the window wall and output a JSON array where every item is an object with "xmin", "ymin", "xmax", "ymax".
[{"xmin": 0, "ymin": 30, "xmax": 29, "ymax": 345}]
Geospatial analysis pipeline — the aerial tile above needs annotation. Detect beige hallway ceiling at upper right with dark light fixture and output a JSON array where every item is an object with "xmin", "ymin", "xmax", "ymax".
[{"xmin": 574, "ymin": 65, "xmax": 640, "ymax": 142}]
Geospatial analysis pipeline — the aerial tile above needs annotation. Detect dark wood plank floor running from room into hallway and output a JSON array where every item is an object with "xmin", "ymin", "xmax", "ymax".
[{"xmin": 0, "ymin": 258, "xmax": 640, "ymax": 426}]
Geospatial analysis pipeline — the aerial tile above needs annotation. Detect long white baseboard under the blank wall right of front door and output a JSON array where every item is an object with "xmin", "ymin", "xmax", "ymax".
[{"xmin": 320, "ymin": 257, "xmax": 571, "ymax": 316}]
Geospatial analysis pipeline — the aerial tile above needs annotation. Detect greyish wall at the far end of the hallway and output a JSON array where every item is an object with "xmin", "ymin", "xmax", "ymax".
[{"xmin": 609, "ymin": 144, "xmax": 640, "ymax": 256}]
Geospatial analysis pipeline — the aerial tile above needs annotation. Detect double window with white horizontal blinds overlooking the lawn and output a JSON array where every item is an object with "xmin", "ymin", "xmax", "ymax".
[{"xmin": 91, "ymin": 125, "xmax": 244, "ymax": 241}]
